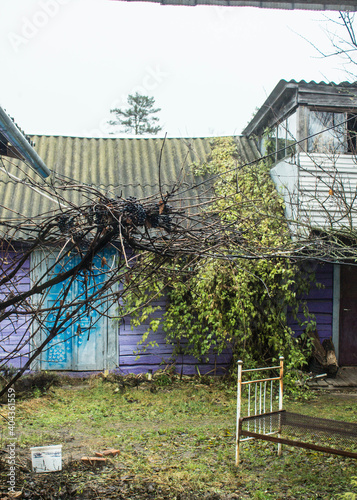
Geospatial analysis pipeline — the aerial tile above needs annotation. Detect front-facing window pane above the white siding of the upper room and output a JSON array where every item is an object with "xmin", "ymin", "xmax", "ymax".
[{"xmin": 307, "ymin": 110, "xmax": 346, "ymax": 153}]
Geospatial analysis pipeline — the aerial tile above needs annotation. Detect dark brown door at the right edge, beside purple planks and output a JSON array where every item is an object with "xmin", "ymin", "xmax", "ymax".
[{"xmin": 339, "ymin": 265, "xmax": 357, "ymax": 366}]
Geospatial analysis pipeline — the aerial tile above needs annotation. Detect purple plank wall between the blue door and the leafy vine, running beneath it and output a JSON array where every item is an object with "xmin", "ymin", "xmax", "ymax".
[{"xmin": 119, "ymin": 299, "xmax": 232, "ymax": 375}]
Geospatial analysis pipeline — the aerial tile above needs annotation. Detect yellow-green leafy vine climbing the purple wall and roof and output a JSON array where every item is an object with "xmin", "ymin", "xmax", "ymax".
[{"xmin": 128, "ymin": 138, "xmax": 314, "ymax": 374}]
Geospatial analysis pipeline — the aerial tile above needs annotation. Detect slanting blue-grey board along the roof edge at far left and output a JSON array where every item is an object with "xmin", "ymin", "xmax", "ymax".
[{"xmin": 0, "ymin": 107, "xmax": 51, "ymax": 179}]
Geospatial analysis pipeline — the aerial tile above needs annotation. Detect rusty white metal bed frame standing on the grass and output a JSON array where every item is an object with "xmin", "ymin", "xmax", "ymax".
[{"xmin": 236, "ymin": 356, "xmax": 357, "ymax": 466}]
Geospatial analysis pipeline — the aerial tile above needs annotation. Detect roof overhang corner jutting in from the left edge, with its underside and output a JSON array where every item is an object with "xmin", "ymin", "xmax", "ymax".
[{"xmin": 0, "ymin": 107, "xmax": 51, "ymax": 178}]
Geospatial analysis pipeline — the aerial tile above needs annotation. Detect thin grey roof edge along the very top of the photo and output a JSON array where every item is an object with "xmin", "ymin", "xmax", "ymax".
[{"xmin": 115, "ymin": 0, "xmax": 357, "ymax": 11}]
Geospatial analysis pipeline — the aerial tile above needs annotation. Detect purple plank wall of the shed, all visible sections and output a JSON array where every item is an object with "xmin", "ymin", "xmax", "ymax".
[{"xmin": 0, "ymin": 250, "xmax": 333, "ymax": 374}]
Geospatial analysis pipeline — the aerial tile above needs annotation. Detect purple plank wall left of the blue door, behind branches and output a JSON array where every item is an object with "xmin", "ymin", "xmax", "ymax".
[{"xmin": 0, "ymin": 252, "xmax": 30, "ymax": 368}]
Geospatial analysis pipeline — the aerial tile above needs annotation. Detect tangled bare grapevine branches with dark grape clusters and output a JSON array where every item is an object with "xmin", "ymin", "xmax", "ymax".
[{"xmin": 0, "ymin": 172, "xmax": 241, "ymax": 390}]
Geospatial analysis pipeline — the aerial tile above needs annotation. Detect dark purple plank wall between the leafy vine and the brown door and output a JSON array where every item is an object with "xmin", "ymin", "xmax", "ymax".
[{"xmin": 288, "ymin": 264, "xmax": 333, "ymax": 342}]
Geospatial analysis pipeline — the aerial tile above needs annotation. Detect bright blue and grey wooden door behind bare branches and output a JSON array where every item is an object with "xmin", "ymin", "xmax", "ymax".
[{"xmin": 35, "ymin": 249, "xmax": 117, "ymax": 371}]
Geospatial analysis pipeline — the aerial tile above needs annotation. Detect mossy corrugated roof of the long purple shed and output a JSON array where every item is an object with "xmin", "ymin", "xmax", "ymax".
[{"xmin": 0, "ymin": 136, "xmax": 259, "ymax": 225}]
